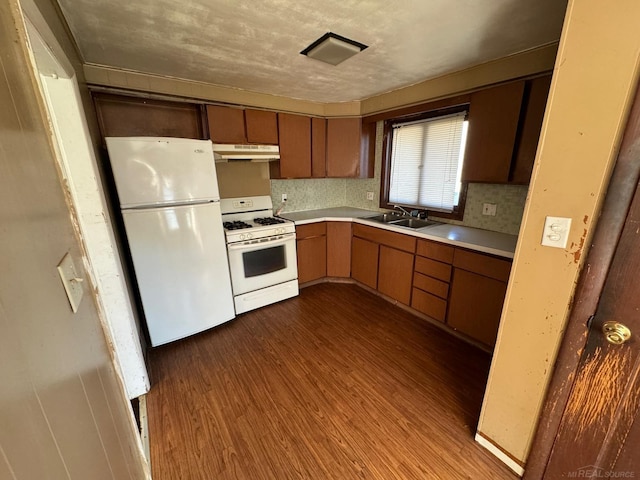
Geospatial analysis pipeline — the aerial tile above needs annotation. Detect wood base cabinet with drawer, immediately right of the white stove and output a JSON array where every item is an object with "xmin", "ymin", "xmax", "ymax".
[{"xmin": 296, "ymin": 222, "xmax": 327, "ymax": 284}]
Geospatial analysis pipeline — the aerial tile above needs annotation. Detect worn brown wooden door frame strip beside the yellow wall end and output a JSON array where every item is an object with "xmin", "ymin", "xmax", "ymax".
[{"xmin": 524, "ymin": 79, "xmax": 640, "ymax": 480}]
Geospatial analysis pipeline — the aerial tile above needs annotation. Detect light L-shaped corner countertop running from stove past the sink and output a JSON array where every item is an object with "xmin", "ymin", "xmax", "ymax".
[{"xmin": 280, "ymin": 207, "xmax": 518, "ymax": 258}]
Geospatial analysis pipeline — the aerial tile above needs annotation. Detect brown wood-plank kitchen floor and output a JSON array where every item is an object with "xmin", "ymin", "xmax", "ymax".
[{"xmin": 147, "ymin": 284, "xmax": 517, "ymax": 480}]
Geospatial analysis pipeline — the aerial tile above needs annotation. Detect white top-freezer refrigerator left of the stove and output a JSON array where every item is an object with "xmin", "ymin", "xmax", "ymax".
[{"xmin": 106, "ymin": 137, "xmax": 235, "ymax": 346}]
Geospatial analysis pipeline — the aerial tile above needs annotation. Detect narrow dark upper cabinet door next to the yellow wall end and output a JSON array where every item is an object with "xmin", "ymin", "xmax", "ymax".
[{"xmin": 509, "ymin": 75, "xmax": 551, "ymax": 185}]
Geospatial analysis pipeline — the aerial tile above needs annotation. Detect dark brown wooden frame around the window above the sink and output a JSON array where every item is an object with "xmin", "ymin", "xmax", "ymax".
[{"xmin": 380, "ymin": 102, "xmax": 469, "ymax": 220}]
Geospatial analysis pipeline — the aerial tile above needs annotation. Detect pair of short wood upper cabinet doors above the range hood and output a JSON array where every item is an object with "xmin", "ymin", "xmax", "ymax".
[{"xmin": 207, "ymin": 105, "xmax": 278, "ymax": 145}]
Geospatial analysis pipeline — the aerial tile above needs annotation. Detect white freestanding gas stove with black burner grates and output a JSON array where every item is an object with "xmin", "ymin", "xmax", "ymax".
[{"xmin": 220, "ymin": 196, "xmax": 298, "ymax": 314}]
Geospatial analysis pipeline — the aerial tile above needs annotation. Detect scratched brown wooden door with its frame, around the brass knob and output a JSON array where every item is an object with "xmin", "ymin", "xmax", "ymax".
[{"xmin": 525, "ymin": 84, "xmax": 640, "ymax": 480}]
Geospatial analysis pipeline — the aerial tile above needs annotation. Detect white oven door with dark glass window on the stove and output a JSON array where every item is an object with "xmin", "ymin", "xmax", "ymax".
[{"xmin": 227, "ymin": 233, "xmax": 298, "ymax": 295}]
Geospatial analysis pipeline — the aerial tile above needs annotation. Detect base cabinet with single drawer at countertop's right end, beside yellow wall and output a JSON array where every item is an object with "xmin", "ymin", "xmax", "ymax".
[{"xmin": 447, "ymin": 248, "xmax": 511, "ymax": 347}]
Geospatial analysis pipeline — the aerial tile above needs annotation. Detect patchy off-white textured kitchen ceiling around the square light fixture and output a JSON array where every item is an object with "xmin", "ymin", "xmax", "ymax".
[{"xmin": 53, "ymin": 0, "xmax": 567, "ymax": 102}]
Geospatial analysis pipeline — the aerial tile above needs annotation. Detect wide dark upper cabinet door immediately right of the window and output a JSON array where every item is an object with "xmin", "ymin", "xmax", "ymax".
[{"xmin": 462, "ymin": 81, "xmax": 524, "ymax": 183}]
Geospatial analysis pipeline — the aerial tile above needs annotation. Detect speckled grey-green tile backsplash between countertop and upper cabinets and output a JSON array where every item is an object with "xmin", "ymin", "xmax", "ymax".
[{"xmin": 271, "ymin": 122, "xmax": 528, "ymax": 235}]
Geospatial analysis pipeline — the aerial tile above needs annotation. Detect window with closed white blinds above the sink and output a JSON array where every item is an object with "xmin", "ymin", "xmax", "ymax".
[{"xmin": 386, "ymin": 109, "xmax": 468, "ymax": 218}]
